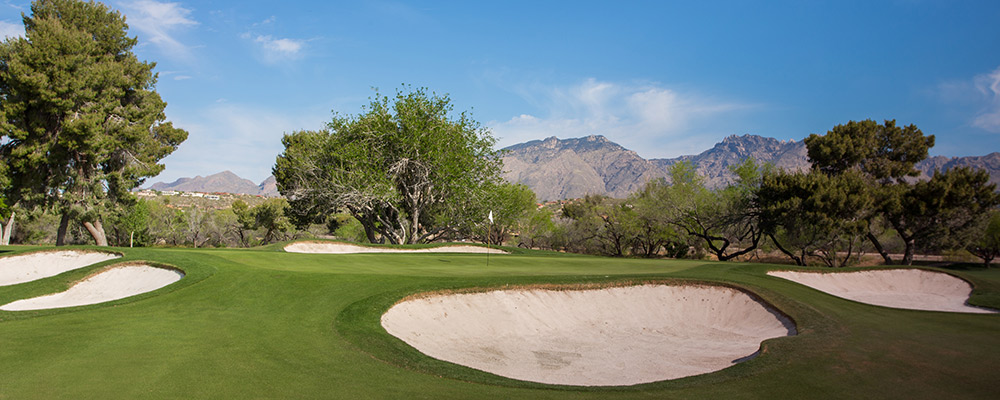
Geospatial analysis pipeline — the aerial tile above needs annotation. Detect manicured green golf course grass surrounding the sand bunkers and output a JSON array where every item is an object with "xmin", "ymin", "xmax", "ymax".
[{"xmin": 0, "ymin": 246, "xmax": 1000, "ymax": 399}]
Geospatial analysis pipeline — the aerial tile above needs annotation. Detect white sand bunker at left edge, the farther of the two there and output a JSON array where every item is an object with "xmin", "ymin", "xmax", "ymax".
[{"xmin": 0, "ymin": 250, "xmax": 121, "ymax": 286}]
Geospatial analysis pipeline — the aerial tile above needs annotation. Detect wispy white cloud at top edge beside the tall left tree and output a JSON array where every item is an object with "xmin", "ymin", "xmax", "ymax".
[{"xmin": 123, "ymin": 0, "xmax": 198, "ymax": 58}]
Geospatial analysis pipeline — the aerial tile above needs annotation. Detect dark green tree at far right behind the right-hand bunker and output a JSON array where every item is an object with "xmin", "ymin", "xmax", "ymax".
[{"xmin": 805, "ymin": 120, "xmax": 997, "ymax": 265}]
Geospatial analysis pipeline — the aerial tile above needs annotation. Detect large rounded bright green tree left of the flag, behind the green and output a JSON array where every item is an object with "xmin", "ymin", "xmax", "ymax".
[{"xmin": 273, "ymin": 89, "xmax": 501, "ymax": 243}]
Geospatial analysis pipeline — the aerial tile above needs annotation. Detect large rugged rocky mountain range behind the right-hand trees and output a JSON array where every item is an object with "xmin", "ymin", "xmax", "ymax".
[{"xmin": 504, "ymin": 135, "xmax": 1000, "ymax": 200}]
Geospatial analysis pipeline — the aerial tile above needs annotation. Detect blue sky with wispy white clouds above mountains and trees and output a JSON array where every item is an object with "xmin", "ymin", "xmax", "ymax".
[{"xmin": 0, "ymin": 0, "xmax": 1000, "ymax": 185}]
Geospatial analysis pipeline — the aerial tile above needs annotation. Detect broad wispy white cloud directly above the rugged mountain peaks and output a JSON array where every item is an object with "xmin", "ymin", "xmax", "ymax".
[{"xmin": 487, "ymin": 79, "xmax": 753, "ymax": 157}]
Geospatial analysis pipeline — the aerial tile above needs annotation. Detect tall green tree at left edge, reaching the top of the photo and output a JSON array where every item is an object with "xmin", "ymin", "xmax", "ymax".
[{"xmin": 0, "ymin": 0, "xmax": 187, "ymax": 246}]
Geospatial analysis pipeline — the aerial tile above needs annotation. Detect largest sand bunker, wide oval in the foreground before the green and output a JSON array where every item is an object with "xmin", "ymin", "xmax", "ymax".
[{"xmin": 382, "ymin": 285, "xmax": 794, "ymax": 386}]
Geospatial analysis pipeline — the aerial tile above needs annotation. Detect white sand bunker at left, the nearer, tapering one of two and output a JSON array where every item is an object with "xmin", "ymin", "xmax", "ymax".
[{"xmin": 0, "ymin": 265, "xmax": 184, "ymax": 311}]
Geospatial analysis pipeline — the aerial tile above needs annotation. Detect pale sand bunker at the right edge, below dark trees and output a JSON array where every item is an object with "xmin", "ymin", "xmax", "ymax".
[{"xmin": 767, "ymin": 269, "xmax": 995, "ymax": 314}]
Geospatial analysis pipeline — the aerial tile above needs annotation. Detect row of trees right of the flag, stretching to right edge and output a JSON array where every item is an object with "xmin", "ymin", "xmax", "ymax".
[{"xmin": 540, "ymin": 120, "xmax": 1000, "ymax": 267}]
